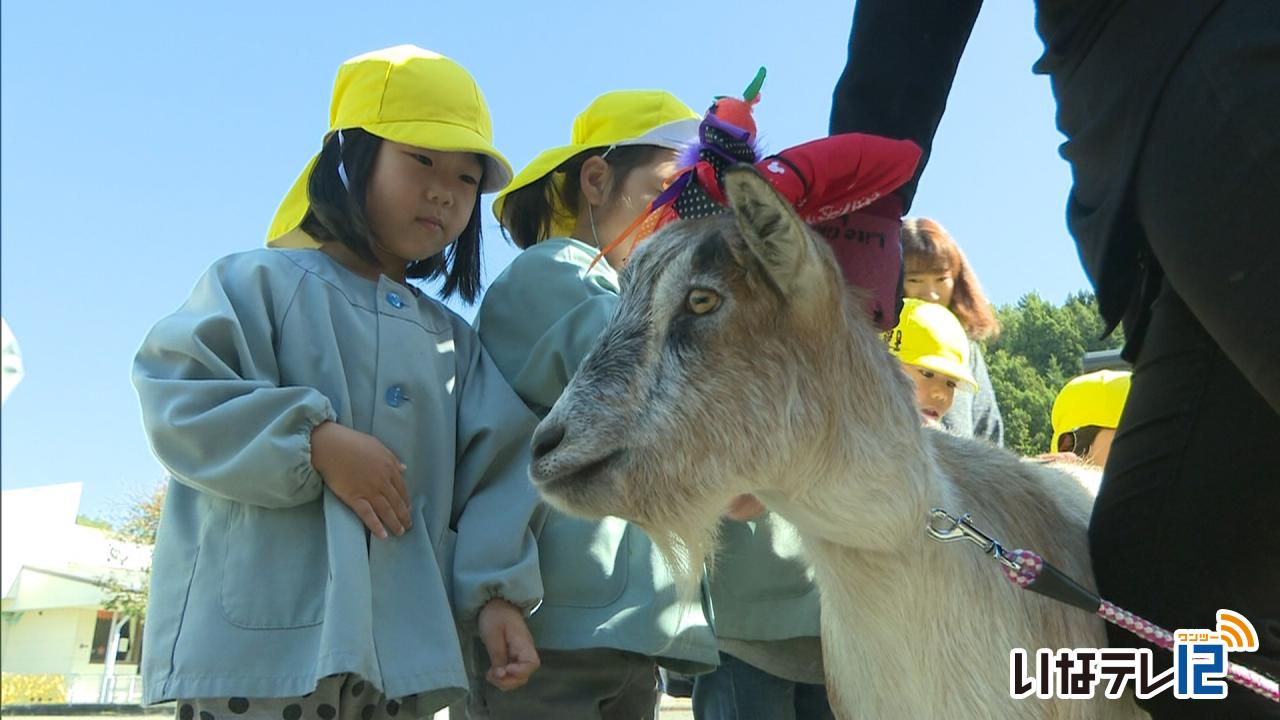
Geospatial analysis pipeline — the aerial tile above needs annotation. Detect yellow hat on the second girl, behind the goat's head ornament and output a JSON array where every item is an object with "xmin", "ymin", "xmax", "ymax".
[{"xmin": 493, "ymin": 90, "xmax": 701, "ymax": 236}]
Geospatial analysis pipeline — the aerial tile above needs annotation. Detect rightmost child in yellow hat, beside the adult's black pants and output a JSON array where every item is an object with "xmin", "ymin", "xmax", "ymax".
[{"xmin": 1050, "ymin": 370, "xmax": 1133, "ymax": 469}]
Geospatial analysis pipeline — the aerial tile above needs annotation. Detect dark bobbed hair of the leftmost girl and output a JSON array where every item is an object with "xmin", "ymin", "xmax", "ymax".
[{"xmin": 301, "ymin": 128, "xmax": 483, "ymax": 302}]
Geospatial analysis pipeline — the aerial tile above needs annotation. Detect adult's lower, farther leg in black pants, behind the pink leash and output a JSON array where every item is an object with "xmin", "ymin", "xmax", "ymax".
[{"xmin": 1089, "ymin": 283, "xmax": 1280, "ymax": 719}]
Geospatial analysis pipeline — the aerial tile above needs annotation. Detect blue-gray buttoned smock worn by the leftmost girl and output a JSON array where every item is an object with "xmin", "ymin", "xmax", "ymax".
[{"xmin": 133, "ymin": 250, "xmax": 541, "ymax": 711}]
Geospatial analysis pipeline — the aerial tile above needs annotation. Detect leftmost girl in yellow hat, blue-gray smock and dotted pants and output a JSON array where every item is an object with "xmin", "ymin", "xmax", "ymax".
[{"xmin": 133, "ymin": 45, "xmax": 541, "ymax": 720}]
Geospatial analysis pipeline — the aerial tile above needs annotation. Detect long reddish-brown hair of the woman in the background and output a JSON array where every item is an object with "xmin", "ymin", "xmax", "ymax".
[{"xmin": 902, "ymin": 218, "xmax": 1000, "ymax": 340}]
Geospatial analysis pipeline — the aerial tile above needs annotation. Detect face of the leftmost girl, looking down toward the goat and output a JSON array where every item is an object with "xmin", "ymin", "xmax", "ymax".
[{"xmin": 365, "ymin": 140, "xmax": 484, "ymax": 272}]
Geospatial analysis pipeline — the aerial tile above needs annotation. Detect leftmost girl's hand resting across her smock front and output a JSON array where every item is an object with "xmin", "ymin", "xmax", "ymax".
[{"xmin": 311, "ymin": 421, "xmax": 413, "ymax": 539}]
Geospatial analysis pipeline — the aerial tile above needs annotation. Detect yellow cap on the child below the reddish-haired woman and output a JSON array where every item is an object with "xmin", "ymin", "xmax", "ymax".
[{"xmin": 884, "ymin": 297, "xmax": 978, "ymax": 391}]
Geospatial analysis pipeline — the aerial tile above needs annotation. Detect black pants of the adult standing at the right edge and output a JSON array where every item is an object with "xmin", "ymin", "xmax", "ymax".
[{"xmin": 1089, "ymin": 1, "xmax": 1280, "ymax": 719}]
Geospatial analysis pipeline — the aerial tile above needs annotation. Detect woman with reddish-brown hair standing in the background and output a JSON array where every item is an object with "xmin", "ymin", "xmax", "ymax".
[{"xmin": 902, "ymin": 218, "xmax": 1005, "ymax": 445}]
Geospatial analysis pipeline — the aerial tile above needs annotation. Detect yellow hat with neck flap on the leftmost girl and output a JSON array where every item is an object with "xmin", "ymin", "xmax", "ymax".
[{"xmin": 266, "ymin": 45, "xmax": 511, "ymax": 247}]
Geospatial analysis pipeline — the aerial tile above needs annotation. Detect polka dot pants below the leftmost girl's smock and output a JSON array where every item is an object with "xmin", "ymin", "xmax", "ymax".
[{"xmin": 177, "ymin": 674, "xmax": 419, "ymax": 720}]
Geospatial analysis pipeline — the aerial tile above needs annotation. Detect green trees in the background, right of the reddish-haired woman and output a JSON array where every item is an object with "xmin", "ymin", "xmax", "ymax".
[{"xmin": 983, "ymin": 292, "xmax": 1124, "ymax": 455}]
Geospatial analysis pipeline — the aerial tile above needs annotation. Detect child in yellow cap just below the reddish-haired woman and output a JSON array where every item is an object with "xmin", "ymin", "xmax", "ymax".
[{"xmin": 884, "ymin": 297, "xmax": 978, "ymax": 427}]
